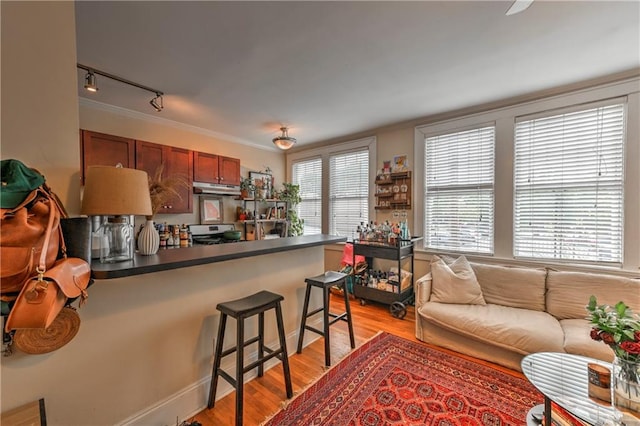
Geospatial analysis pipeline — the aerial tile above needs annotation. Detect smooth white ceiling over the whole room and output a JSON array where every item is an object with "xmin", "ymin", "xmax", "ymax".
[{"xmin": 76, "ymin": 0, "xmax": 640, "ymax": 148}]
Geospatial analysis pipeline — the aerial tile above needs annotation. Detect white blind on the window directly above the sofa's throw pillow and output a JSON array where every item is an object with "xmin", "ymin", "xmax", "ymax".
[{"xmin": 424, "ymin": 126, "xmax": 495, "ymax": 254}]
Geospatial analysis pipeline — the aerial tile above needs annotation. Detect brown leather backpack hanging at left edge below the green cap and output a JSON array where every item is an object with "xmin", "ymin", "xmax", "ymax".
[{"xmin": 0, "ymin": 185, "xmax": 66, "ymax": 301}]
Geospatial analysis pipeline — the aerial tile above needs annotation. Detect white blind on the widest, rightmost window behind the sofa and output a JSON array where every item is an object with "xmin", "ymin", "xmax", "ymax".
[{"xmin": 514, "ymin": 103, "xmax": 625, "ymax": 264}]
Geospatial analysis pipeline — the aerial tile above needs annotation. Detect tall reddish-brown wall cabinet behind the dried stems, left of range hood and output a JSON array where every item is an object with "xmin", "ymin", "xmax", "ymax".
[{"xmin": 135, "ymin": 140, "xmax": 193, "ymax": 214}]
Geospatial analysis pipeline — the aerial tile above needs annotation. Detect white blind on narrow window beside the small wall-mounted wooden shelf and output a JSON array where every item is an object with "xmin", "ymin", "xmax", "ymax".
[{"xmin": 329, "ymin": 149, "xmax": 369, "ymax": 237}]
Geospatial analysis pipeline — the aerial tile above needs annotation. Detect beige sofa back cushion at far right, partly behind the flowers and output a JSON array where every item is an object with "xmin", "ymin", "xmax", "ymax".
[{"xmin": 547, "ymin": 270, "xmax": 640, "ymax": 319}]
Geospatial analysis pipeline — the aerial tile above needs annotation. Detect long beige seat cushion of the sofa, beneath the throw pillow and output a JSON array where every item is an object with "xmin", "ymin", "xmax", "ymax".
[{"xmin": 418, "ymin": 302, "xmax": 564, "ymax": 355}]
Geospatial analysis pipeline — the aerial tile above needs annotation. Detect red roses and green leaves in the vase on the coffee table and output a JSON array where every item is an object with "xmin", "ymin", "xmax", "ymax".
[{"xmin": 587, "ymin": 295, "xmax": 640, "ymax": 363}]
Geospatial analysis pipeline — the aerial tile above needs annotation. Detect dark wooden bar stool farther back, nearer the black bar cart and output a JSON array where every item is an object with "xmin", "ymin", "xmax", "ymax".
[{"xmin": 297, "ymin": 271, "xmax": 356, "ymax": 367}]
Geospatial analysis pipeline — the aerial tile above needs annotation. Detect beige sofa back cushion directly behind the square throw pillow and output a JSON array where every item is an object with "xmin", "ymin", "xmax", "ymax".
[{"xmin": 471, "ymin": 263, "xmax": 547, "ymax": 311}]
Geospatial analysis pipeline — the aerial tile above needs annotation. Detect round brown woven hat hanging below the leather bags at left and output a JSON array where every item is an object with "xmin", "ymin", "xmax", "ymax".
[{"xmin": 13, "ymin": 306, "xmax": 80, "ymax": 355}]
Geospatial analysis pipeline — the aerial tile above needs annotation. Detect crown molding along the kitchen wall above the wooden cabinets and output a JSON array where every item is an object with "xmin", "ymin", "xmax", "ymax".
[{"xmin": 78, "ymin": 96, "xmax": 279, "ymax": 152}]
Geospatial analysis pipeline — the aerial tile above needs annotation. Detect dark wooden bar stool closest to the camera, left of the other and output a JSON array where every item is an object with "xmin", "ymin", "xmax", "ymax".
[{"xmin": 208, "ymin": 290, "xmax": 293, "ymax": 426}]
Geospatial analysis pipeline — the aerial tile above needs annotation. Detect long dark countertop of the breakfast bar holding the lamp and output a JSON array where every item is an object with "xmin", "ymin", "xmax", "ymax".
[{"xmin": 91, "ymin": 234, "xmax": 347, "ymax": 280}]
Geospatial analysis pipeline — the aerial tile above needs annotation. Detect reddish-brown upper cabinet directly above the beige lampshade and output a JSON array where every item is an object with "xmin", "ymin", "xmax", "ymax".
[{"xmin": 80, "ymin": 130, "xmax": 136, "ymax": 185}]
